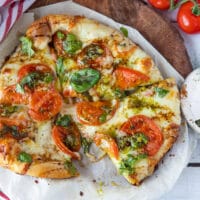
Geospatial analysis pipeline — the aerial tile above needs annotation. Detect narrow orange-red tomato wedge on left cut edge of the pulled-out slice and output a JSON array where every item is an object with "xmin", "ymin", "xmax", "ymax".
[{"xmin": 94, "ymin": 133, "xmax": 119, "ymax": 159}]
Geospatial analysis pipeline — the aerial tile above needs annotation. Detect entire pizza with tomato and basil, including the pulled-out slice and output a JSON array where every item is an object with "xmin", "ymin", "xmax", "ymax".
[{"xmin": 0, "ymin": 15, "xmax": 181, "ymax": 185}]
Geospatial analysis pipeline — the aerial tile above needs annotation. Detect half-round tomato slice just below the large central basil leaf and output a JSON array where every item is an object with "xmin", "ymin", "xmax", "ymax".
[{"xmin": 76, "ymin": 101, "xmax": 119, "ymax": 126}]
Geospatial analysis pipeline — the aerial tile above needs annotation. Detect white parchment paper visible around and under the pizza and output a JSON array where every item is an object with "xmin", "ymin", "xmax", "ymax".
[{"xmin": 0, "ymin": 1, "xmax": 195, "ymax": 200}]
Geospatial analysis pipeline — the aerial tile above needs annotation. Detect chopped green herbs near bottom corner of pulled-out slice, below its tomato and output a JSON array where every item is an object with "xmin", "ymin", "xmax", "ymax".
[{"xmin": 119, "ymin": 154, "xmax": 147, "ymax": 174}]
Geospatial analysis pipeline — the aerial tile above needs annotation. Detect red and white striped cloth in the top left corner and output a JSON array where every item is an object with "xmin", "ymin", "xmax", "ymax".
[{"xmin": 0, "ymin": 0, "xmax": 35, "ymax": 43}]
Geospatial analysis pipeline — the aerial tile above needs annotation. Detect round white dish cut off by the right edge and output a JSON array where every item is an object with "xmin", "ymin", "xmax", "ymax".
[{"xmin": 181, "ymin": 68, "xmax": 200, "ymax": 133}]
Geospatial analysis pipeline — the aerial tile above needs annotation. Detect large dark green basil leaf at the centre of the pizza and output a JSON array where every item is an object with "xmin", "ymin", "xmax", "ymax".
[{"xmin": 70, "ymin": 68, "xmax": 100, "ymax": 93}]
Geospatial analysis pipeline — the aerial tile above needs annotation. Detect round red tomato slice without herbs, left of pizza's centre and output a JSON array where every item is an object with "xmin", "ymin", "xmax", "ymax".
[{"xmin": 29, "ymin": 90, "xmax": 62, "ymax": 121}]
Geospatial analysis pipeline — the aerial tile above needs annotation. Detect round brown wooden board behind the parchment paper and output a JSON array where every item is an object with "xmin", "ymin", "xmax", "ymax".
[{"xmin": 31, "ymin": 0, "xmax": 192, "ymax": 77}]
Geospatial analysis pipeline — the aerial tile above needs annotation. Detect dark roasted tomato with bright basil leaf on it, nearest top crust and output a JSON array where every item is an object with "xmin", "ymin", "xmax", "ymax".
[{"xmin": 54, "ymin": 31, "xmax": 82, "ymax": 55}]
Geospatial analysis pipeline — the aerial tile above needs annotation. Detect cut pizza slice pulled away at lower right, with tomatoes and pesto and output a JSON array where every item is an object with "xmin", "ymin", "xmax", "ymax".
[{"xmin": 66, "ymin": 79, "xmax": 181, "ymax": 185}]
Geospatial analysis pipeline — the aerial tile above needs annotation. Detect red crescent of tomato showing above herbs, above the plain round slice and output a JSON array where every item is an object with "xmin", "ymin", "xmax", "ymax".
[{"xmin": 17, "ymin": 63, "xmax": 53, "ymax": 82}]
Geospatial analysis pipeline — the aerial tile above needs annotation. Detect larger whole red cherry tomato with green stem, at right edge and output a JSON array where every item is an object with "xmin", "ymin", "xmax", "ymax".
[{"xmin": 177, "ymin": 0, "xmax": 200, "ymax": 34}]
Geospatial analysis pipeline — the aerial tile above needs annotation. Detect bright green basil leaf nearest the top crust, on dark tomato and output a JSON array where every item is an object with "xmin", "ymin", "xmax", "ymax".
[{"xmin": 63, "ymin": 33, "xmax": 82, "ymax": 54}]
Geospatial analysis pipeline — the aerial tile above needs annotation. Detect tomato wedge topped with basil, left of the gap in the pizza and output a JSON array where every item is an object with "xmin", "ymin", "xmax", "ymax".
[{"xmin": 52, "ymin": 115, "xmax": 81, "ymax": 159}]
